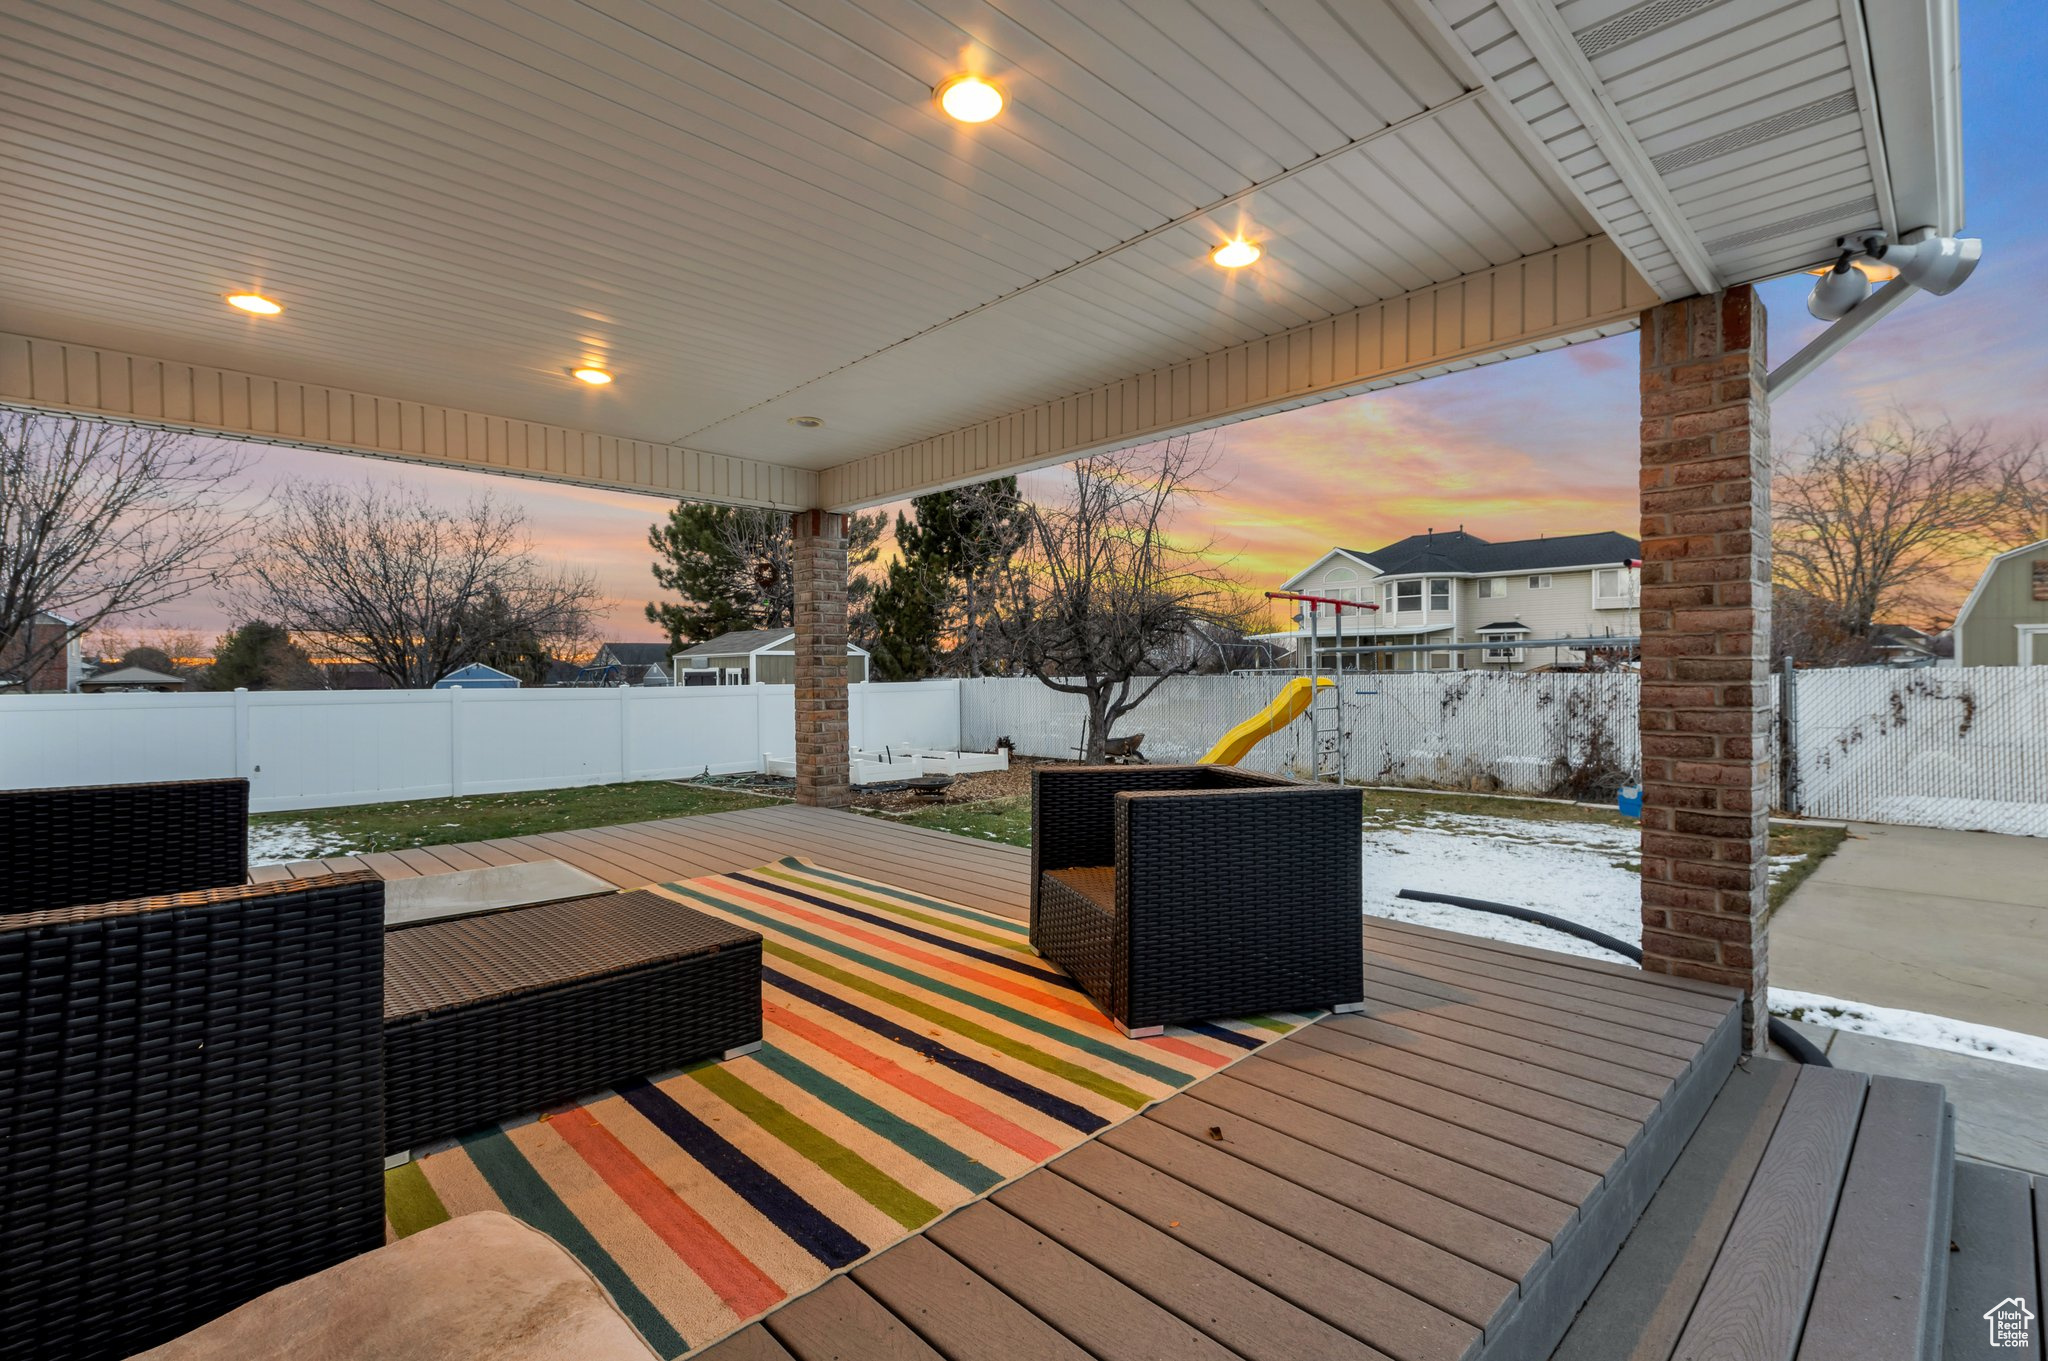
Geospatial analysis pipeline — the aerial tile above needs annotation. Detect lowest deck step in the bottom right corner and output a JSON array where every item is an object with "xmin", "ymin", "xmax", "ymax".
[{"xmin": 1942, "ymin": 1162, "xmax": 2048, "ymax": 1361}]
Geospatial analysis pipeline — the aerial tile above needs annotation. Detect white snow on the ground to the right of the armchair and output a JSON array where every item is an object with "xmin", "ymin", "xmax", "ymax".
[{"xmin": 1364, "ymin": 813, "xmax": 2048, "ymax": 1068}]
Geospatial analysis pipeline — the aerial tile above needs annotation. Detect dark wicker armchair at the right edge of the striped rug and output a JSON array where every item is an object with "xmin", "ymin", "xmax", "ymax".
[{"xmin": 1030, "ymin": 765, "xmax": 1364, "ymax": 1036}]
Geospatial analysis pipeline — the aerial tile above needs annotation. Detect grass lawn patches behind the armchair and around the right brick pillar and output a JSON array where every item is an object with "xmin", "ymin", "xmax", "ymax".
[{"xmin": 903, "ymin": 790, "xmax": 1847, "ymax": 907}]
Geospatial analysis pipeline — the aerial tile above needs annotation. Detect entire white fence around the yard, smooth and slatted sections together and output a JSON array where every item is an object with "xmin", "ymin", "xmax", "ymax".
[{"xmin": 0, "ymin": 667, "xmax": 2048, "ymax": 837}]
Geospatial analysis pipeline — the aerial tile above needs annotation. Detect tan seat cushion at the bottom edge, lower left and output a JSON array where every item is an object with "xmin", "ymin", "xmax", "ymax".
[{"xmin": 133, "ymin": 1212, "xmax": 655, "ymax": 1361}]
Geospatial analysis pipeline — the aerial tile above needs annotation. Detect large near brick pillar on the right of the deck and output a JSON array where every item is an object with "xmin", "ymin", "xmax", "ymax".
[{"xmin": 1640, "ymin": 287, "xmax": 1774, "ymax": 1050}]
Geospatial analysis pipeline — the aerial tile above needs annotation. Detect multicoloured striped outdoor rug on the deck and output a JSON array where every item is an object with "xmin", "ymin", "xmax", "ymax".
[{"xmin": 385, "ymin": 860, "xmax": 1309, "ymax": 1357}]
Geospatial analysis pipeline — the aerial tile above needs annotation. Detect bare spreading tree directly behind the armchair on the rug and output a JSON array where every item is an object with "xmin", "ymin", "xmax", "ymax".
[{"xmin": 995, "ymin": 436, "xmax": 1251, "ymax": 761}]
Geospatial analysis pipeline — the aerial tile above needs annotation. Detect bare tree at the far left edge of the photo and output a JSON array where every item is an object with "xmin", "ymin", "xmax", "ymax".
[{"xmin": 0, "ymin": 411, "xmax": 250, "ymax": 691}]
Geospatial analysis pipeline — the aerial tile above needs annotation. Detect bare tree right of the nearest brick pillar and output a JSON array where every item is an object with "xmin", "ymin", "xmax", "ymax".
[{"xmin": 1772, "ymin": 411, "xmax": 2009, "ymax": 641}]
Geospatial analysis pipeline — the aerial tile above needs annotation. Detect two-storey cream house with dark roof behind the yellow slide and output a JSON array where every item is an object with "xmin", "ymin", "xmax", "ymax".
[{"xmin": 1257, "ymin": 528, "xmax": 1642, "ymax": 671}]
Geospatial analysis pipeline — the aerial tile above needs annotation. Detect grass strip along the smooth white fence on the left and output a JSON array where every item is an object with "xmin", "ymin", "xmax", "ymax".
[{"xmin": 250, "ymin": 780, "xmax": 776, "ymax": 860}]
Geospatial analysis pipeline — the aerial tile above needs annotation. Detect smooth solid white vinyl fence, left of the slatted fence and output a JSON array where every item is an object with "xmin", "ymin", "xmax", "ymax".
[{"xmin": 0, "ymin": 682, "xmax": 961, "ymax": 813}]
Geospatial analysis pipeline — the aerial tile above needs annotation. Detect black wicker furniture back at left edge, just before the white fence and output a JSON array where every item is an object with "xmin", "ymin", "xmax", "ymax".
[{"xmin": 0, "ymin": 780, "xmax": 250, "ymax": 911}]
